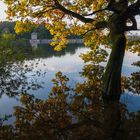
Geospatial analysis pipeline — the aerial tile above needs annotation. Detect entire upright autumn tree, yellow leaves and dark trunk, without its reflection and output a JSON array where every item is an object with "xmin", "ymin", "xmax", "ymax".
[{"xmin": 4, "ymin": 0, "xmax": 140, "ymax": 100}]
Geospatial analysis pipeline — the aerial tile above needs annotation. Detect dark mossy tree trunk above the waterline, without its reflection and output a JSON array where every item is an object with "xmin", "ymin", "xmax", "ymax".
[{"xmin": 103, "ymin": 32, "xmax": 126, "ymax": 101}]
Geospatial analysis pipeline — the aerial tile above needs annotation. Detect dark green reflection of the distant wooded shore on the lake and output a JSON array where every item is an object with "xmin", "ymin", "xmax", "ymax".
[{"xmin": 0, "ymin": 39, "xmax": 85, "ymax": 60}]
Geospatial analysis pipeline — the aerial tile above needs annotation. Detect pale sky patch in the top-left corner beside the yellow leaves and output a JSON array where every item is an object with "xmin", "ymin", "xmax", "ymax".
[{"xmin": 0, "ymin": 2, "xmax": 6, "ymax": 21}]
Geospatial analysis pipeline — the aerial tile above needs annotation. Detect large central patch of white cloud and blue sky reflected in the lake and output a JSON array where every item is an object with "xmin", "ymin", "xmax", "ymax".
[{"xmin": 27, "ymin": 48, "xmax": 87, "ymax": 99}]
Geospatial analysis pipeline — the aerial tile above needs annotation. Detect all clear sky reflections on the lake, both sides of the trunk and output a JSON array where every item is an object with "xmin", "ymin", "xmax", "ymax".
[{"xmin": 0, "ymin": 48, "xmax": 140, "ymax": 122}]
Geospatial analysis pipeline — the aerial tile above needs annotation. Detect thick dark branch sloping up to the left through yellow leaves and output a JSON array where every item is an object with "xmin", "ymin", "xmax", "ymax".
[{"xmin": 54, "ymin": 0, "xmax": 94, "ymax": 23}]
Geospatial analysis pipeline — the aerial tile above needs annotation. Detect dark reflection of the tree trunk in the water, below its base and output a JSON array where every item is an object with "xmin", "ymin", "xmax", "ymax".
[{"xmin": 101, "ymin": 101, "xmax": 122, "ymax": 140}]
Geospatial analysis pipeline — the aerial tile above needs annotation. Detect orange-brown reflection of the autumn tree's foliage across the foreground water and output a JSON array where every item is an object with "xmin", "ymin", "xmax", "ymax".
[{"xmin": 0, "ymin": 49, "xmax": 140, "ymax": 140}]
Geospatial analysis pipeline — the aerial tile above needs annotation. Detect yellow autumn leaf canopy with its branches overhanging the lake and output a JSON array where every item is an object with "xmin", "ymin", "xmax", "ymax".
[{"xmin": 4, "ymin": 0, "xmax": 140, "ymax": 50}]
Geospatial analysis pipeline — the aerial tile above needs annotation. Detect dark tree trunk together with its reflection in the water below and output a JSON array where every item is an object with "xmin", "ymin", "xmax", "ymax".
[{"xmin": 103, "ymin": 20, "xmax": 126, "ymax": 140}]
